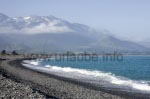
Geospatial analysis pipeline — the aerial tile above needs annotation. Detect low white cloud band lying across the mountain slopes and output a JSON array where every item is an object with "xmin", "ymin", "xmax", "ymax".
[{"xmin": 0, "ymin": 23, "xmax": 73, "ymax": 34}]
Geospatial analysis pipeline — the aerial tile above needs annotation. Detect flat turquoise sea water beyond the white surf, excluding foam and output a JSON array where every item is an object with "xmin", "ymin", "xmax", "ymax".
[{"xmin": 40, "ymin": 56, "xmax": 150, "ymax": 81}]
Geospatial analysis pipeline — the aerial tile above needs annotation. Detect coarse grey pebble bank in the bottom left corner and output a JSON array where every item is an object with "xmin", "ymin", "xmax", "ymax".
[{"xmin": 0, "ymin": 72, "xmax": 46, "ymax": 99}]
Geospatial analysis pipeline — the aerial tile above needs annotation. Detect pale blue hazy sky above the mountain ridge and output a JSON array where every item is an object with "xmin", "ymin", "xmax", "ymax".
[{"xmin": 0, "ymin": 0, "xmax": 150, "ymax": 42}]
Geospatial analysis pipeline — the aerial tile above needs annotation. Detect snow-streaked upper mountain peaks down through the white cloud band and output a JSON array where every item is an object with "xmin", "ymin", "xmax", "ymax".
[{"xmin": 0, "ymin": 14, "xmax": 90, "ymax": 34}]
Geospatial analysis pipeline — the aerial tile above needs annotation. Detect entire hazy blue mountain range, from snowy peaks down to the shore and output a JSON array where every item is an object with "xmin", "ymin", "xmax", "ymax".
[{"xmin": 0, "ymin": 13, "xmax": 146, "ymax": 53}]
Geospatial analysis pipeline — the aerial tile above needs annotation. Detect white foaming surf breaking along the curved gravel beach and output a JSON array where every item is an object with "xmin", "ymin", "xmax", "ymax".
[{"xmin": 24, "ymin": 61, "xmax": 150, "ymax": 92}]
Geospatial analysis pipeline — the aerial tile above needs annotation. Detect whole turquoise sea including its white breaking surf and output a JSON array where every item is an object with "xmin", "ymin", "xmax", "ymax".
[{"xmin": 23, "ymin": 56, "xmax": 150, "ymax": 93}]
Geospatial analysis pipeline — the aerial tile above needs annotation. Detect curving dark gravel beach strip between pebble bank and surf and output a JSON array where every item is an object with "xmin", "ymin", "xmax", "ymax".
[{"xmin": 0, "ymin": 58, "xmax": 150, "ymax": 99}]
